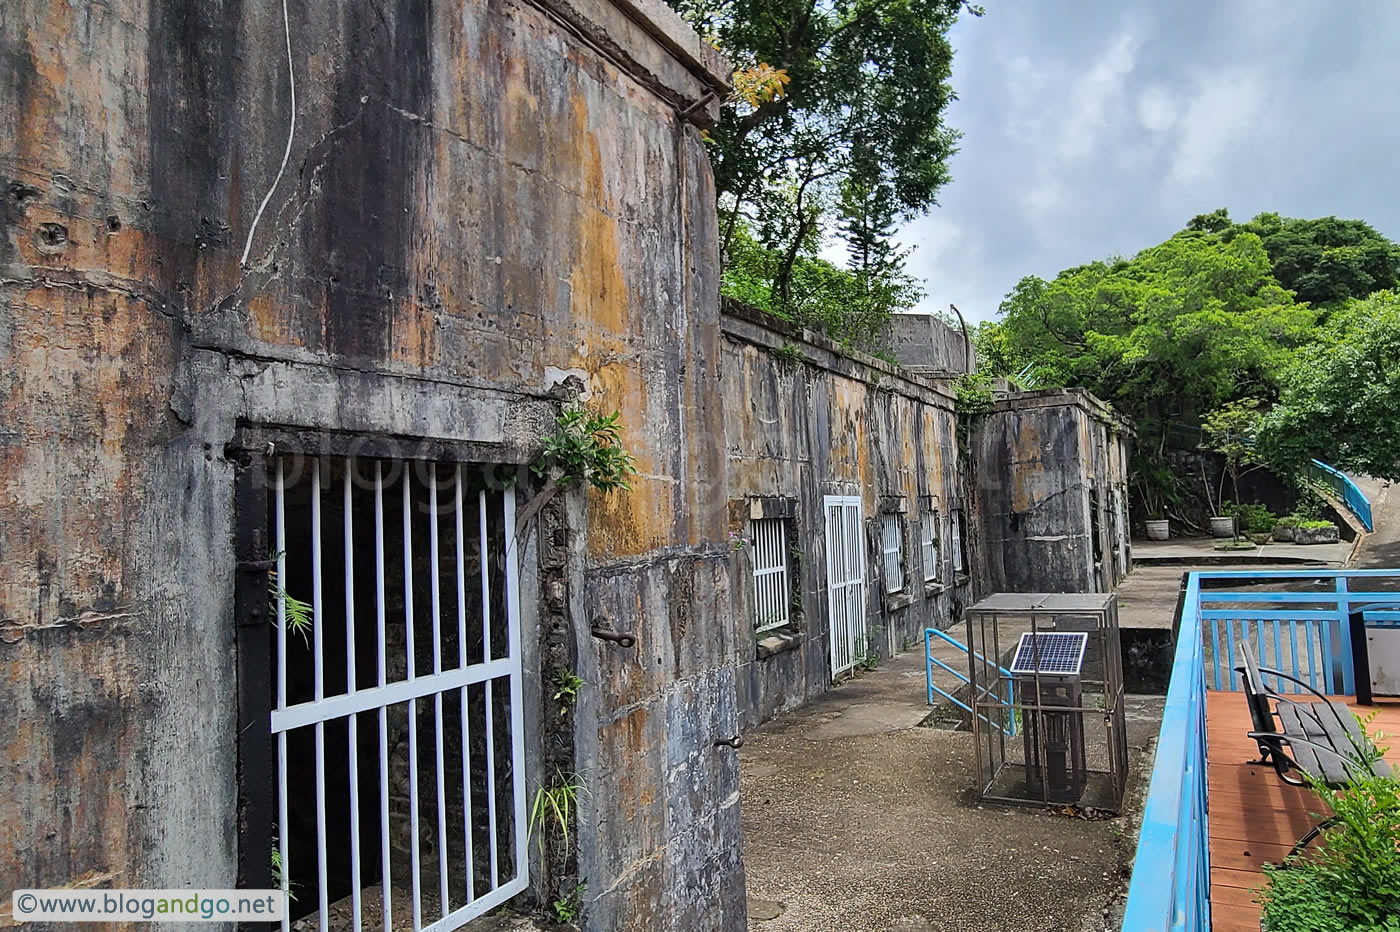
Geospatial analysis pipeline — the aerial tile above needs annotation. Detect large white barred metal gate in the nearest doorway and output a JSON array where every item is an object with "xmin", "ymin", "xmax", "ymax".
[{"xmin": 239, "ymin": 445, "xmax": 528, "ymax": 932}]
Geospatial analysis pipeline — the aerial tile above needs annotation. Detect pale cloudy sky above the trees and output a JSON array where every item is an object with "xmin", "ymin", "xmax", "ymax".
[{"xmin": 900, "ymin": 0, "xmax": 1400, "ymax": 319}]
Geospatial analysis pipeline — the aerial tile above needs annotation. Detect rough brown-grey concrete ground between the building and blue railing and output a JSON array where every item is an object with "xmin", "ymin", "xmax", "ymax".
[{"xmin": 741, "ymin": 649, "xmax": 1162, "ymax": 932}]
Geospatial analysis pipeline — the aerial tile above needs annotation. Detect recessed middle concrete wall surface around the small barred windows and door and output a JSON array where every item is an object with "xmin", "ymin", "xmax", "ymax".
[{"xmin": 720, "ymin": 308, "xmax": 970, "ymax": 725}]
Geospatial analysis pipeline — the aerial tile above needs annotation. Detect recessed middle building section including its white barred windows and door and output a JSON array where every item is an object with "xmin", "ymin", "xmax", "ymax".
[{"xmin": 721, "ymin": 308, "xmax": 972, "ymax": 723}]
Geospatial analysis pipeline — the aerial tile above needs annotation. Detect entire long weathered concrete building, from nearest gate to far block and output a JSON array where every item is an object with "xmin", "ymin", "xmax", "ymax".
[{"xmin": 0, "ymin": 0, "xmax": 1123, "ymax": 932}]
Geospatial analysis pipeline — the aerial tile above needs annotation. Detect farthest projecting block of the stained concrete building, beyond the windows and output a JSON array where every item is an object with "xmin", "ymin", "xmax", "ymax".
[{"xmin": 970, "ymin": 389, "xmax": 1131, "ymax": 593}]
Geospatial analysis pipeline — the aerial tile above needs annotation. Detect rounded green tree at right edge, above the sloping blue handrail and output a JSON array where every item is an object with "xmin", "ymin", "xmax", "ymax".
[{"xmin": 1260, "ymin": 291, "xmax": 1400, "ymax": 481}]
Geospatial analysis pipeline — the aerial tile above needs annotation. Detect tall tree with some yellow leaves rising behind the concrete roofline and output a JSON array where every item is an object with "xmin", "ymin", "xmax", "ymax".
[{"xmin": 669, "ymin": 0, "xmax": 981, "ymax": 340}]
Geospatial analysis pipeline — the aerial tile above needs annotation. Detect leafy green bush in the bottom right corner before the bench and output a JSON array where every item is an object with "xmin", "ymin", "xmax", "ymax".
[{"xmin": 1256, "ymin": 722, "xmax": 1400, "ymax": 932}]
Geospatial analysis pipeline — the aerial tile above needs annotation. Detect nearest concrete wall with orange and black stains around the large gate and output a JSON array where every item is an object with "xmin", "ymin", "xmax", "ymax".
[{"xmin": 0, "ymin": 0, "xmax": 748, "ymax": 932}]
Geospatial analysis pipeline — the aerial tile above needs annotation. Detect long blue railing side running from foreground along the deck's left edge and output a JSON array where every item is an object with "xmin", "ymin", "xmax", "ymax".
[{"xmin": 1123, "ymin": 572, "xmax": 1211, "ymax": 932}]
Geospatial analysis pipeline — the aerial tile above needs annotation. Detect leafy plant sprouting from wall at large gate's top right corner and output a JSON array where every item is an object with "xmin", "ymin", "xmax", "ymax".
[{"xmin": 515, "ymin": 402, "xmax": 637, "ymax": 535}]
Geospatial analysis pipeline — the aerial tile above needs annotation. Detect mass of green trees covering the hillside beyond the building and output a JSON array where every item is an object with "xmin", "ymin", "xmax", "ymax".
[{"xmin": 977, "ymin": 210, "xmax": 1400, "ymax": 489}]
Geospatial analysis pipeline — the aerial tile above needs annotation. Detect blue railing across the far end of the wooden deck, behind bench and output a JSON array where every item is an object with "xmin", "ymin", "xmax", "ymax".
[{"xmin": 1191, "ymin": 570, "xmax": 1400, "ymax": 696}]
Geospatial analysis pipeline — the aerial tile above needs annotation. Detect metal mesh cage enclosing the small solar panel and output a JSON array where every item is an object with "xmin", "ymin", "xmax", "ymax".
[{"xmin": 967, "ymin": 592, "xmax": 1127, "ymax": 812}]
